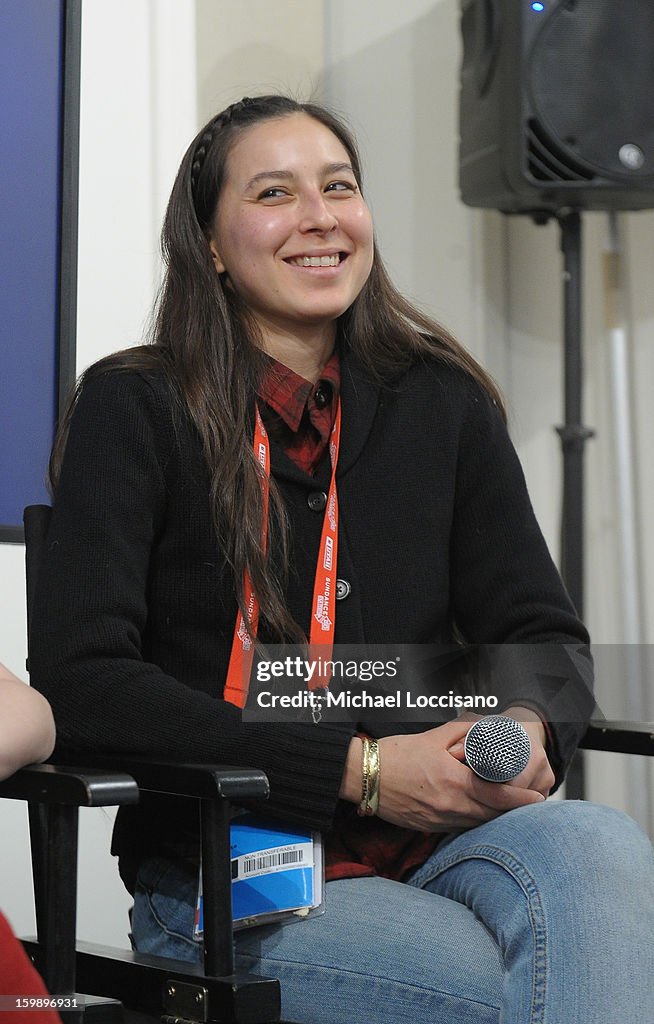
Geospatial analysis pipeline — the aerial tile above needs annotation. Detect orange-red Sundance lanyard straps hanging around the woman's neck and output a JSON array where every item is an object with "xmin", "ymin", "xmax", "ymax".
[{"xmin": 223, "ymin": 399, "xmax": 341, "ymax": 708}]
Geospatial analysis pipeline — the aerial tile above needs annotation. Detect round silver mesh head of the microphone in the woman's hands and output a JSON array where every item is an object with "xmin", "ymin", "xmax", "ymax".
[{"xmin": 464, "ymin": 715, "xmax": 531, "ymax": 782}]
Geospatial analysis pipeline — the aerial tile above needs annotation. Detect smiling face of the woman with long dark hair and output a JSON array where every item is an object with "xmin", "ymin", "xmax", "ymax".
[{"xmin": 210, "ymin": 113, "xmax": 373, "ymax": 348}]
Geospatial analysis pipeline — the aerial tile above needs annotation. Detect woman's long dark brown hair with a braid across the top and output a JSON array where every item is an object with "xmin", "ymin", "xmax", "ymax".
[{"xmin": 50, "ymin": 95, "xmax": 503, "ymax": 642}]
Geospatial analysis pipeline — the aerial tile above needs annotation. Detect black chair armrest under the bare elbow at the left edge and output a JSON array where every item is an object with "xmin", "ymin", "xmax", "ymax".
[{"xmin": 0, "ymin": 764, "xmax": 138, "ymax": 807}]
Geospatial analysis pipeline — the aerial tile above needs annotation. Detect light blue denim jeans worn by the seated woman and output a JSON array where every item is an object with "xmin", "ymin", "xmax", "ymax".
[{"xmin": 132, "ymin": 801, "xmax": 654, "ymax": 1024}]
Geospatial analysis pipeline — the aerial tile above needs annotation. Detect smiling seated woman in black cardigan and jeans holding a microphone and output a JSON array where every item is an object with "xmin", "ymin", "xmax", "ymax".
[{"xmin": 30, "ymin": 96, "xmax": 654, "ymax": 1024}]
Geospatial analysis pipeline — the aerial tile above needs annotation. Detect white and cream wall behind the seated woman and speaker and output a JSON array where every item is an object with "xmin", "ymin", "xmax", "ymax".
[{"xmin": 0, "ymin": 0, "xmax": 654, "ymax": 943}]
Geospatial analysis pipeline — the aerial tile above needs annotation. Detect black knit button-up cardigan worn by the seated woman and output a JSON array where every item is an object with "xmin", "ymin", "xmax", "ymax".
[{"xmin": 31, "ymin": 353, "xmax": 592, "ymax": 872}]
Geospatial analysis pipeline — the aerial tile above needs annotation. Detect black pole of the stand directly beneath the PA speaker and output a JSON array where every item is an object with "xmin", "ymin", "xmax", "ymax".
[{"xmin": 557, "ymin": 209, "xmax": 595, "ymax": 800}]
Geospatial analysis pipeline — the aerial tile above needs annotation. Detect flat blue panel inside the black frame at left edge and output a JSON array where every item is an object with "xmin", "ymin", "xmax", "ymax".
[{"xmin": 0, "ymin": 0, "xmax": 63, "ymax": 539}]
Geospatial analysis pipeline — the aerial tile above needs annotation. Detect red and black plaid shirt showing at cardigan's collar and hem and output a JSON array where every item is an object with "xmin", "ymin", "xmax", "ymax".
[{"xmin": 259, "ymin": 350, "xmax": 442, "ymax": 882}]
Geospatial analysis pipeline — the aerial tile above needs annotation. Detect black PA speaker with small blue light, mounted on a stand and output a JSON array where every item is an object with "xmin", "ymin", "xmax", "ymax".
[{"xmin": 460, "ymin": 0, "xmax": 654, "ymax": 213}]
